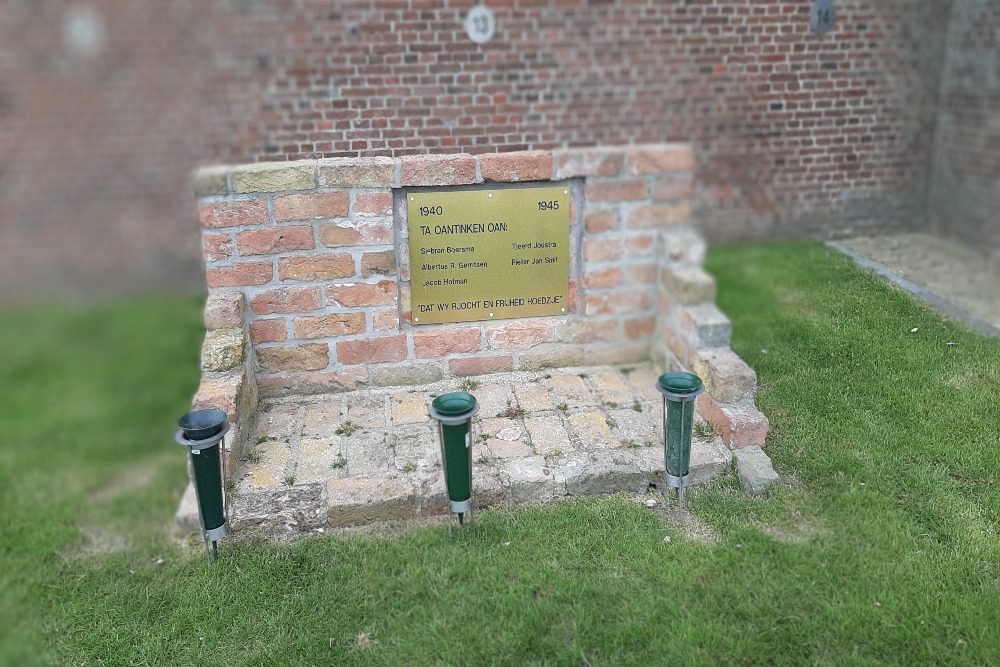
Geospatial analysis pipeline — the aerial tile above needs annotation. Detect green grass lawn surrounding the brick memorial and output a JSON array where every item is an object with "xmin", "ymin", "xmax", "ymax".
[{"xmin": 0, "ymin": 244, "xmax": 1000, "ymax": 667}]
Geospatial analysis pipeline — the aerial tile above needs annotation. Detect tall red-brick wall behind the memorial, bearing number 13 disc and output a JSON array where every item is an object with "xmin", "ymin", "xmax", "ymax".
[{"xmin": 0, "ymin": 0, "xmax": 972, "ymax": 298}]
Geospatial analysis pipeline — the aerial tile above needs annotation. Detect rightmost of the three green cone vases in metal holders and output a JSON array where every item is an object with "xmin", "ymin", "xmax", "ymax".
[{"xmin": 656, "ymin": 372, "xmax": 705, "ymax": 507}]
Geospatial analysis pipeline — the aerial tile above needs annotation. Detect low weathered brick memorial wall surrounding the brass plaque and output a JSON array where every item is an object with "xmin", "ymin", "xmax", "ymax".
[{"xmin": 195, "ymin": 144, "xmax": 755, "ymax": 426}]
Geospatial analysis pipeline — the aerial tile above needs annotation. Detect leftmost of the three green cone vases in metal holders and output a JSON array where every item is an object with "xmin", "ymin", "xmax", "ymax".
[{"xmin": 174, "ymin": 409, "xmax": 229, "ymax": 563}]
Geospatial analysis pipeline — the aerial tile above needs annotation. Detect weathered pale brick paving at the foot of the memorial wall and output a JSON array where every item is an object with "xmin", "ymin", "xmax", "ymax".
[{"xmin": 231, "ymin": 365, "xmax": 732, "ymax": 539}]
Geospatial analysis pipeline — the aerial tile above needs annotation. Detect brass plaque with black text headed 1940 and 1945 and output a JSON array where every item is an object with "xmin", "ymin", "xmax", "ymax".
[{"xmin": 406, "ymin": 187, "xmax": 570, "ymax": 324}]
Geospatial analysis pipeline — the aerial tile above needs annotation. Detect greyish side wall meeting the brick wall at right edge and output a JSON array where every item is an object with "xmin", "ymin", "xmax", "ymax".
[{"xmin": 930, "ymin": 0, "xmax": 1000, "ymax": 256}]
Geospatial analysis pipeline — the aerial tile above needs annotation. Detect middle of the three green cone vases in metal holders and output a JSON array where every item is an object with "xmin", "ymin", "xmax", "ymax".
[{"xmin": 431, "ymin": 391, "xmax": 479, "ymax": 537}]
